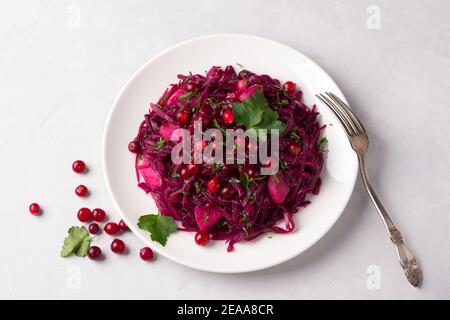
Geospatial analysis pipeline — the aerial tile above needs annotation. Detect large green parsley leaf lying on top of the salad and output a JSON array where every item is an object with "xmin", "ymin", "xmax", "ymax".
[{"xmin": 233, "ymin": 90, "xmax": 286, "ymax": 137}]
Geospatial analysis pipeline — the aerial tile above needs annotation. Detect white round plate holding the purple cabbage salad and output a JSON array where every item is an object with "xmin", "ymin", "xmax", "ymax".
[{"xmin": 103, "ymin": 34, "xmax": 358, "ymax": 273}]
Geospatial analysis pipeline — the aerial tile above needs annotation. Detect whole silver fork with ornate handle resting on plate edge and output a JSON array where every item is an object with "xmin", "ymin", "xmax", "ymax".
[{"xmin": 316, "ymin": 92, "xmax": 422, "ymax": 287}]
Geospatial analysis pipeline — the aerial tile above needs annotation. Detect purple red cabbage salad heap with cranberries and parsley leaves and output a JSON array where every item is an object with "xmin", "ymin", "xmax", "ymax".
[{"xmin": 129, "ymin": 66, "xmax": 327, "ymax": 251}]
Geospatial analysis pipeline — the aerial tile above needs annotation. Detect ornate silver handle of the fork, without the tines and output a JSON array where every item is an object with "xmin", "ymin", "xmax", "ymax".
[{"xmin": 357, "ymin": 156, "xmax": 422, "ymax": 287}]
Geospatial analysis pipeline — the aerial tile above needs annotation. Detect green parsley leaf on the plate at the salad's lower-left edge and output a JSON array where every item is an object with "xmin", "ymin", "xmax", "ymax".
[{"xmin": 138, "ymin": 211, "xmax": 177, "ymax": 246}]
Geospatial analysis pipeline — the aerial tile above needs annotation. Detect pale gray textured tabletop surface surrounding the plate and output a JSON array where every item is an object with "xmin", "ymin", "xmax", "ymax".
[{"xmin": 0, "ymin": 0, "xmax": 450, "ymax": 299}]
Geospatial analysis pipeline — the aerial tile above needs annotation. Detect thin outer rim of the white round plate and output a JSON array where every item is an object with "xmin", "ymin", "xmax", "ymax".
[{"xmin": 101, "ymin": 33, "xmax": 358, "ymax": 274}]
